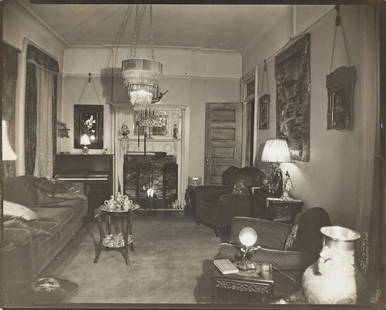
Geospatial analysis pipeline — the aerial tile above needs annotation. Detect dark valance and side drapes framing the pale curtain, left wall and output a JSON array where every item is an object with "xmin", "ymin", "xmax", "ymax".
[{"xmin": 24, "ymin": 45, "xmax": 59, "ymax": 175}]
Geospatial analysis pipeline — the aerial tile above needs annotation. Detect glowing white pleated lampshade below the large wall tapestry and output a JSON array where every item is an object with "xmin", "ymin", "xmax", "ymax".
[{"xmin": 261, "ymin": 139, "xmax": 291, "ymax": 163}]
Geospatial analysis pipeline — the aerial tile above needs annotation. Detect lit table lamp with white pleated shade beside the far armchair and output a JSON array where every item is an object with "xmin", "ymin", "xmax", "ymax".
[{"xmin": 261, "ymin": 139, "xmax": 291, "ymax": 197}]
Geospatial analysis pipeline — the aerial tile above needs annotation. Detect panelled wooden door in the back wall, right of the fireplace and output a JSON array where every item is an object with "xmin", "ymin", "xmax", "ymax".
[{"xmin": 204, "ymin": 103, "xmax": 242, "ymax": 185}]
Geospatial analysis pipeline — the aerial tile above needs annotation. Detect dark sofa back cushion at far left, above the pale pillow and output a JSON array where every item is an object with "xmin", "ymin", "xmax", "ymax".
[{"xmin": 3, "ymin": 175, "xmax": 38, "ymax": 207}]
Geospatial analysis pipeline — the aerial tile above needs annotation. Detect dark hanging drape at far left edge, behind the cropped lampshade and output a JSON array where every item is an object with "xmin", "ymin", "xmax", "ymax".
[{"xmin": 2, "ymin": 42, "xmax": 19, "ymax": 177}]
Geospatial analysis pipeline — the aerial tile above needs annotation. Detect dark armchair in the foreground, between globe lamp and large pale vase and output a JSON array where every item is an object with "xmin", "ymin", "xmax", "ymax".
[{"xmin": 217, "ymin": 208, "xmax": 331, "ymax": 295}]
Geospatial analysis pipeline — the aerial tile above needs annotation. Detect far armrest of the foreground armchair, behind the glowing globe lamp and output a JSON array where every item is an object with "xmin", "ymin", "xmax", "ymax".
[{"xmin": 231, "ymin": 217, "xmax": 292, "ymax": 250}]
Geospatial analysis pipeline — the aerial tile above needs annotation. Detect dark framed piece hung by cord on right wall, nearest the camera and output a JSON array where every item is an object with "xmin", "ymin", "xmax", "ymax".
[{"xmin": 326, "ymin": 67, "xmax": 356, "ymax": 129}]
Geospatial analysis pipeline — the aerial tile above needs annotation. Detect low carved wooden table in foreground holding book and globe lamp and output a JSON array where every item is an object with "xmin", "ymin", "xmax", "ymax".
[{"xmin": 211, "ymin": 264, "xmax": 274, "ymax": 303}]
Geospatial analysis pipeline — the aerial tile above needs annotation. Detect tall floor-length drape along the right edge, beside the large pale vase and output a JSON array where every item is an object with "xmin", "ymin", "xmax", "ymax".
[{"xmin": 355, "ymin": 6, "xmax": 384, "ymax": 302}]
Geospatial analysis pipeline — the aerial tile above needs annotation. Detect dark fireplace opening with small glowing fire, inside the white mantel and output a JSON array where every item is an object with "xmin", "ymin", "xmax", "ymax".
[{"xmin": 123, "ymin": 152, "xmax": 178, "ymax": 209}]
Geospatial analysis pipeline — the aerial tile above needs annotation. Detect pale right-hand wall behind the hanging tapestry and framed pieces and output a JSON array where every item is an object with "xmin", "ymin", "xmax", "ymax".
[{"xmin": 243, "ymin": 6, "xmax": 367, "ymax": 227}]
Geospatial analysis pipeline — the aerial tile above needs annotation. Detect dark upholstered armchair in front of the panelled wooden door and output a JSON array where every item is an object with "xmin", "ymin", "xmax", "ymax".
[{"xmin": 193, "ymin": 167, "xmax": 265, "ymax": 233}]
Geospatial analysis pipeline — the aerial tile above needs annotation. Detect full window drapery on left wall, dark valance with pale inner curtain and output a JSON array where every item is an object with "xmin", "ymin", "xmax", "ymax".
[{"xmin": 24, "ymin": 45, "xmax": 59, "ymax": 177}]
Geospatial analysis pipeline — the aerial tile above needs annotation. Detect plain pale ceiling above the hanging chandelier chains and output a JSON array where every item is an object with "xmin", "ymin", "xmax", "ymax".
[{"xmin": 20, "ymin": 0, "xmax": 291, "ymax": 52}]
